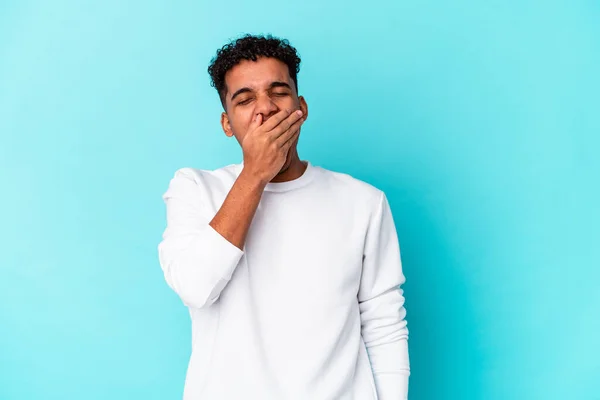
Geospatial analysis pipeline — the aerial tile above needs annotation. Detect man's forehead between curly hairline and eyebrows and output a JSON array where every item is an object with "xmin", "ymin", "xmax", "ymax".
[{"xmin": 225, "ymin": 57, "xmax": 292, "ymax": 94}]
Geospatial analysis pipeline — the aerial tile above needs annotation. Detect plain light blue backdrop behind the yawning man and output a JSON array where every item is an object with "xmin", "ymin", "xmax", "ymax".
[{"xmin": 0, "ymin": 0, "xmax": 600, "ymax": 400}]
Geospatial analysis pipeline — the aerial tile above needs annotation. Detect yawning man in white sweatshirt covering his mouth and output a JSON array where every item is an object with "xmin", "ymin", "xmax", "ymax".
[{"xmin": 159, "ymin": 35, "xmax": 409, "ymax": 400}]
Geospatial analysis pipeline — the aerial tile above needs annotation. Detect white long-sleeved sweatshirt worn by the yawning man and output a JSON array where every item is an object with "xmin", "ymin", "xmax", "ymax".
[{"xmin": 158, "ymin": 162, "xmax": 409, "ymax": 400}]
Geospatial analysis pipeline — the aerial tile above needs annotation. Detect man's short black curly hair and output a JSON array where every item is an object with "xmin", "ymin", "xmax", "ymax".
[{"xmin": 208, "ymin": 34, "xmax": 300, "ymax": 108}]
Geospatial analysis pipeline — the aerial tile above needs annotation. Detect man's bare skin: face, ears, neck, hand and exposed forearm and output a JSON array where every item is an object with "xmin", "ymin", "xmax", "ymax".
[{"xmin": 210, "ymin": 57, "xmax": 308, "ymax": 250}]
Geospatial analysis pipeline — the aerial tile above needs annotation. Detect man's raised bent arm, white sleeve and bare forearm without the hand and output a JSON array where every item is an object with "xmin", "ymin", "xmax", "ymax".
[{"xmin": 158, "ymin": 169, "xmax": 264, "ymax": 308}]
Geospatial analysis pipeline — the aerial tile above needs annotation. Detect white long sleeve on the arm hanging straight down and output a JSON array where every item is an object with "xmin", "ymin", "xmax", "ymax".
[{"xmin": 358, "ymin": 192, "xmax": 410, "ymax": 400}]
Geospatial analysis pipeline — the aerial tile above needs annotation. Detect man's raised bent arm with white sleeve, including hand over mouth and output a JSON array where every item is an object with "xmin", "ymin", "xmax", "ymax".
[{"xmin": 158, "ymin": 110, "xmax": 304, "ymax": 308}]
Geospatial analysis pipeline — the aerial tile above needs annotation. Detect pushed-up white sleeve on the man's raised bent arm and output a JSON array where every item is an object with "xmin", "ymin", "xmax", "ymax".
[{"xmin": 158, "ymin": 169, "xmax": 243, "ymax": 308}]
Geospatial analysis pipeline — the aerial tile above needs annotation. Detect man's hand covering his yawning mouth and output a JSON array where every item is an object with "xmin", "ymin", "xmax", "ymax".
[{"xmin": 241, "ymin": 110, "xmax": 304, "ymax": 184}]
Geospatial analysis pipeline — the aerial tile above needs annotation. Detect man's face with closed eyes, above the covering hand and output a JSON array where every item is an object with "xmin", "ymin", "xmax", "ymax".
[{"xmin": 221, "ymin": 57, "xmax": 308, "ymax": 147}]
